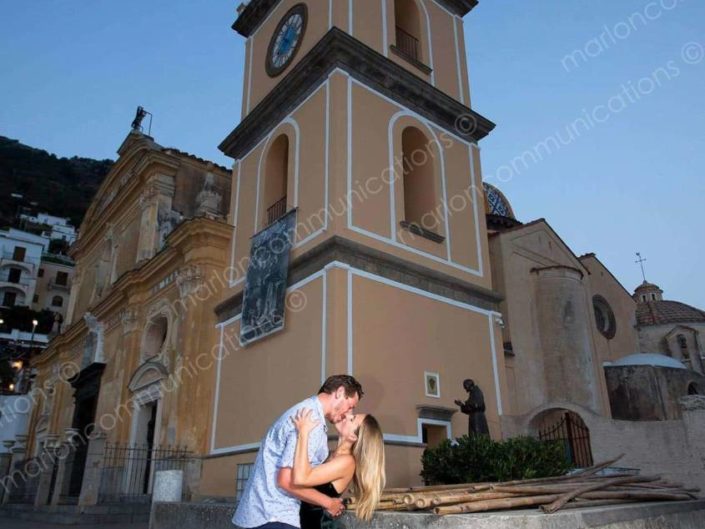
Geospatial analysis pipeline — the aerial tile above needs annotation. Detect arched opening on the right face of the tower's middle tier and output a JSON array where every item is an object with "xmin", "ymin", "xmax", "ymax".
[{"xmin": 401, "ymin": 127, "xmax": 439, "ymax": 232}]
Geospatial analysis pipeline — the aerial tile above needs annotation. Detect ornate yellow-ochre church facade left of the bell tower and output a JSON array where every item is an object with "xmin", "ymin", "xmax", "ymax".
[{"xmin": 19, "ymin": 130, "xmax": 230, "ymax": 505}]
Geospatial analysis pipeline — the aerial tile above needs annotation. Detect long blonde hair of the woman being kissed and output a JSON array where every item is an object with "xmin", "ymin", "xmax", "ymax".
[{"xmin": 352, "ymin": 414, "xmax": 387, "ymax": 521}]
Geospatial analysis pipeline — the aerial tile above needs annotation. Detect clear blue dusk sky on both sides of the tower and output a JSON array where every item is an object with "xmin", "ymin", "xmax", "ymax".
[{"xmin": 0, "ymin": 0, "xmax": 705, "ymax": 309}]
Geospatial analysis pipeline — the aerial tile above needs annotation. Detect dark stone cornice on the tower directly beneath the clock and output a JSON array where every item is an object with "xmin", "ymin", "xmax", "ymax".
[{"xmin": 219, "ymin": 27, "xmax": 495, "ymax": 159}]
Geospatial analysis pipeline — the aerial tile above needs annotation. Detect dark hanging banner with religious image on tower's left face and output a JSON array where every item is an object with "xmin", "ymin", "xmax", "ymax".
[{"xmin": 240, "ymin": 209, "xmax": 296, "ymax": 345}]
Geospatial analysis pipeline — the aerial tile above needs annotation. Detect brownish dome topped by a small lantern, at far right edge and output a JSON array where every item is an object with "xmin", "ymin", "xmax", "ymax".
[{"xmin": 634, "ymin": 281, "xmax": 705, "ymax": 327}]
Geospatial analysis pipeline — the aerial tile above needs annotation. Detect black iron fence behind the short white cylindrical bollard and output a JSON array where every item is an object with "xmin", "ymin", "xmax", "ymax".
[{"xmin": 98, "ymin": 443, "xmax": 193, "ymax": 503}]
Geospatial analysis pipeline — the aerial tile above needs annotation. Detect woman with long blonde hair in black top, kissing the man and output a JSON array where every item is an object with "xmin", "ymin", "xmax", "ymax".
[{"xmin": 292, "ymin": 409, "xmax": 386, "ymax": 529}]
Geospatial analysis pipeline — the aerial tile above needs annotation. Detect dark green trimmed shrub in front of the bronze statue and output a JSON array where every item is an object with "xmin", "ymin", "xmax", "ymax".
[{"xmin": 421, "ymin": 435, "xmax": 571, "ymax": 485}]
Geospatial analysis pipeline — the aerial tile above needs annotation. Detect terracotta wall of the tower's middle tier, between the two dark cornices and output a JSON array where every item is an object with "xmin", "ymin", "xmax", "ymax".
[{"xmin": 231, "ymin": 73, "xmax": 490, "ymax": 289}]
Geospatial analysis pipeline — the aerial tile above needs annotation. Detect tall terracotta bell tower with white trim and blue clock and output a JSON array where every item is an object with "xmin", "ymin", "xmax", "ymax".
[{"xmin": 205, "ymin": 0, "xmax": 504, "ymax": 486}]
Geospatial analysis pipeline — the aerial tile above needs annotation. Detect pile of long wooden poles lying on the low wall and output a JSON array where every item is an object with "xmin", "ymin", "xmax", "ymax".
[{"xmin": 348, "ymin": 456, "xmax": 699, "ymax": 514}]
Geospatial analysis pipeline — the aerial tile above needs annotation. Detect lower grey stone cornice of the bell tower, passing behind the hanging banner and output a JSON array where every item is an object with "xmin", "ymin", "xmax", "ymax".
[{"xmin": 215, "ymin": 236, "xmax": 503, "ymax": 321}]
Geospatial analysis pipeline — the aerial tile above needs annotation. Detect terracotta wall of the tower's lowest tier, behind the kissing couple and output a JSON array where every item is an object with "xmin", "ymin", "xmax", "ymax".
[{"xmin": 209, "ymin": 267, "xmax": 505, "ymax": 495}]
